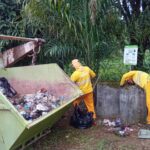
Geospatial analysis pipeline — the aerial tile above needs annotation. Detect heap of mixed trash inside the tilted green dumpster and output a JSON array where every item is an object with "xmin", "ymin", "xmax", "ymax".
[{"xmin": 0, "ymin": 78, "xmax": 64, "ymax": 121}]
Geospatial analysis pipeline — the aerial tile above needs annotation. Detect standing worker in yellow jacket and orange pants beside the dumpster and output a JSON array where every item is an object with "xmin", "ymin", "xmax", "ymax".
[{"xmin": 71, "ymin": 59, "xmax": 96, "ymax": 119}]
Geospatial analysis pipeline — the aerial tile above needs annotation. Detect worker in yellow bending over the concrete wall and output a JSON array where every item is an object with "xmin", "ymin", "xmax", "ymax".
[{"xmin": 120, "ymin": 71, "xmax": 150, "ymax": 124}]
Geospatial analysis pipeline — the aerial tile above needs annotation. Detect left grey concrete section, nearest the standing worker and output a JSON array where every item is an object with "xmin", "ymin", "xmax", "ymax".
[{"xmin": 96, "ymin": 84, "xmax": 120, "ymax": 118}]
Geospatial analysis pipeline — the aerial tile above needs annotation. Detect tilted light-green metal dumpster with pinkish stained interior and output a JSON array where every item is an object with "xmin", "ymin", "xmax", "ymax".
[{"xmin": 0, "ymin": 64, "xmax": 82, "ymax": 150}]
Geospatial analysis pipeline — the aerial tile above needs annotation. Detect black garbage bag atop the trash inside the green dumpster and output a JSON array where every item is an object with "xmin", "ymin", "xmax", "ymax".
[{"xmin": 0, "ymin": 77, "xmax": 17, "ymax": 97}]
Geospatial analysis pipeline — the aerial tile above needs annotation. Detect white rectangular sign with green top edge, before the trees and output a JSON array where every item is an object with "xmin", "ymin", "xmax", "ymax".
[{"xmin": 123, "ymin": 45, "xmax": 138, "ymax": 65}]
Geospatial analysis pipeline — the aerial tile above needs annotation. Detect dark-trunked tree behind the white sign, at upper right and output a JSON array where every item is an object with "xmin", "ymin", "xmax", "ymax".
[{"xmin": 112, "ymin": 0, "xmax": 150, "ymax": 69}]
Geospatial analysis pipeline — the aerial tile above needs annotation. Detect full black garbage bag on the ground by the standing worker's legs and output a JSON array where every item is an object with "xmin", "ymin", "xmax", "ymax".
[{"xmin": 70, "ymin": 106, "xmax": 93, "ymax": 129}]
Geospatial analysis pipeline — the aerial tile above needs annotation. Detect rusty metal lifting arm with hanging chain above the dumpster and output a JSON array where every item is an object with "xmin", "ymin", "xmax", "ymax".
[{"xmin": 0, "ymin": 34, "xmax": 46, "ymax": 68}]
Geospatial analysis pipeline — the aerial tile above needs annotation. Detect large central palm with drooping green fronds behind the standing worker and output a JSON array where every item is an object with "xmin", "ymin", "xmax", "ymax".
[{"xmin": 24, "ymin": 0, "xmax": 124, "ymax": 73}]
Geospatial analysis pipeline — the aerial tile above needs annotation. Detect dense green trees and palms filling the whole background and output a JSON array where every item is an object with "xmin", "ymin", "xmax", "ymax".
[{"xmin": 0, "ymin": 0, "xmax": 150, "ymax": 80}]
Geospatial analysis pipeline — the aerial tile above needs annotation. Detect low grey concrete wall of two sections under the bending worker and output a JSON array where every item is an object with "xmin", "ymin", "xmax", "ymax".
[{"xmin": 96, "ymin": 84, "xmax": 147, "ymax": 124}]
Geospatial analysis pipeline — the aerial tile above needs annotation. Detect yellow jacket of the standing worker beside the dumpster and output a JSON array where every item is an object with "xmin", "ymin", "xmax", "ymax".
[{"xmin": 71, "ymin": 66, "xmax": 96, "ymax": 94}]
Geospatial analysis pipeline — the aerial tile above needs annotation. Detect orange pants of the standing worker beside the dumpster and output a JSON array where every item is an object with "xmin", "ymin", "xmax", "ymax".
[{"xmin": 73, "ymin": 92, "xmax": 96, "ymax": 119}]
